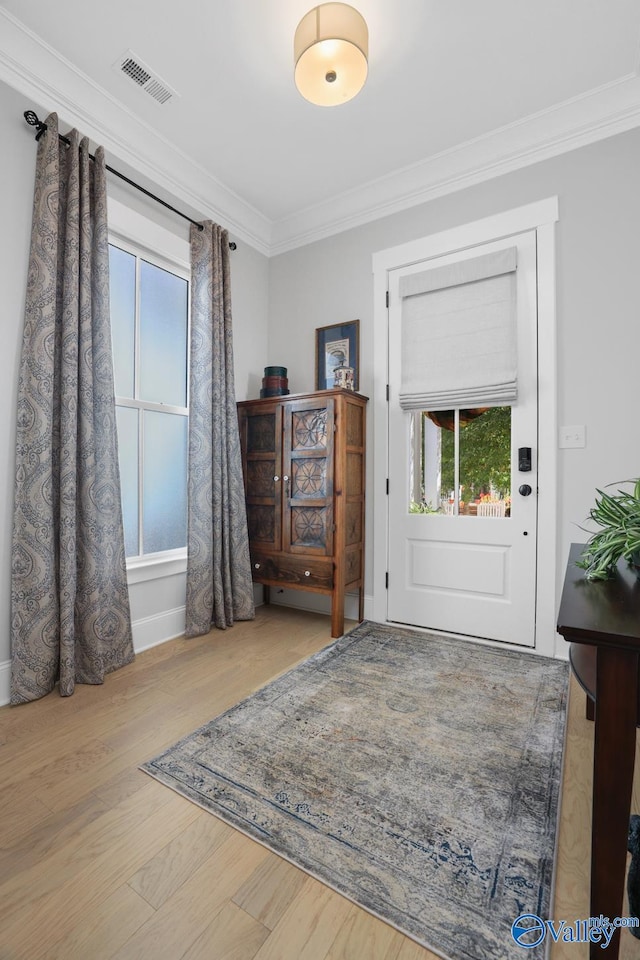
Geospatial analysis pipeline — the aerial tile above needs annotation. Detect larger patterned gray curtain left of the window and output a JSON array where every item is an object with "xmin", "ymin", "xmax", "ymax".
[{"xmin": 11, "ymin": 114, "xmax": 134, "ymax": 704}]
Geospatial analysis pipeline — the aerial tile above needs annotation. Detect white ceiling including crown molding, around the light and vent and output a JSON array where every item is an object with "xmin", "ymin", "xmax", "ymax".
[{"xmin": 0, "ymin": 0, "xmax": 640, "ymax": 253}]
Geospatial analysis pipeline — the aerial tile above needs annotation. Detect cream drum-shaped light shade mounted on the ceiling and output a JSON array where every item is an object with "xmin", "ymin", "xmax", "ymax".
[{"xmin": 293, "ymin": 3, "xmax": 369, "ymax": 107}]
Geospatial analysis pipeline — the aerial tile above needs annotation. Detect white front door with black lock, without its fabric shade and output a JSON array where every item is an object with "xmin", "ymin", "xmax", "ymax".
[{"xmin": 387, "ymin": 231, "xmax": 538, "ymax": 646}]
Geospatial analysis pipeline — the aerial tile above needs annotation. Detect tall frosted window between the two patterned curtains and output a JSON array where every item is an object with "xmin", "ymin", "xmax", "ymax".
[{"xmin": 109, "ymin": 239, "xmax": 189, "ymax": 559}]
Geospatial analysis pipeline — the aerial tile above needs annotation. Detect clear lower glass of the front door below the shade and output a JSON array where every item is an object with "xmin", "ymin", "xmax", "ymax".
[{"xmin": 409, "ymin": 407, "xmax": 511, "ymax": 518}]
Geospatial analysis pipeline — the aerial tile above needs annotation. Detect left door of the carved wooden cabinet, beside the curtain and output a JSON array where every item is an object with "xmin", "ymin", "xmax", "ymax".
[{"xmin": 240, "ymin": 403, "xmax": 282, "ymax": 550}]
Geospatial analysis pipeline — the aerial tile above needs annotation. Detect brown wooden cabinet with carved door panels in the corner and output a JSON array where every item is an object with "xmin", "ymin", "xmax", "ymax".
[{"xmin": 238, "ymin": 390, "xmax": 367, "ymax": 637}]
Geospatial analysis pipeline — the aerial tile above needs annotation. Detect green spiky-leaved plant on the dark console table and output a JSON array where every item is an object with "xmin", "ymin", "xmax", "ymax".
[{"xmin": 577, "ymin": 478, "xmax": 640, "ymax": 580}]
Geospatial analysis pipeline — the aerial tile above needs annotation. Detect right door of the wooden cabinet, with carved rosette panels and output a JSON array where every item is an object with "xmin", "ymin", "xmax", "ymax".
[{"xmin": 282, "ymin": 397, "xmax": 335, "ymax": 556}]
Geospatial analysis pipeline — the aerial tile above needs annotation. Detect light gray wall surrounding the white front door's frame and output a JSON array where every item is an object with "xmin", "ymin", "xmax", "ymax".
[{"xmin": 269, "ymin": 130, "xmax": 640, "ymax": 636}]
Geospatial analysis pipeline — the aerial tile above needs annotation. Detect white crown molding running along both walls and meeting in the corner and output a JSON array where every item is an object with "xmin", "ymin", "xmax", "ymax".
[{"xmin": 0, "ymin": 7, "xmax": 640, "ymax": 256}]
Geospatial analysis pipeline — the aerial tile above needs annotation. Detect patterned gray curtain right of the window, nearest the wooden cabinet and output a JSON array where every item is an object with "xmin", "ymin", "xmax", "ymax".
[{"xmin": 186, "ymin": 221, "xmax": 255, "ymax": 637}]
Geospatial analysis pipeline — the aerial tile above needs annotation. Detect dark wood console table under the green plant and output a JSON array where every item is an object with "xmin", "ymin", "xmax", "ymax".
[{"xmin": 558, "ymin": 543, "xmax": 640, "ymax": 960}]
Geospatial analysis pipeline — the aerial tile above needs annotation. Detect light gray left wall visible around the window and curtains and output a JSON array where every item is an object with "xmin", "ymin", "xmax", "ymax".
[{"xmin": 0, "ymin": 83, "xmax": 269, "ymax": 703}]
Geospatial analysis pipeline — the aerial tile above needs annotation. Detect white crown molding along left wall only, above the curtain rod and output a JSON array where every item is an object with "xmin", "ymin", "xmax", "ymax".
[{"xmin": 0, "ymin": 7, "xmax": 271, "ymax": 255}]
